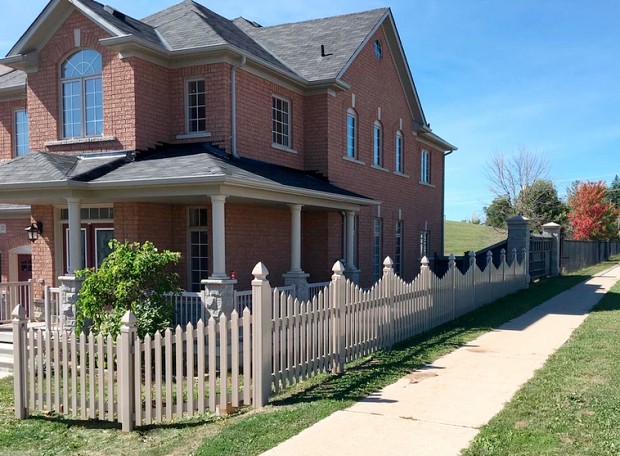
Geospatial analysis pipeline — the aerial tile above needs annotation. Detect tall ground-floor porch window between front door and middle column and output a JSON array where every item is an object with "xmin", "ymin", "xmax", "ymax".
[{"xmin": 187, "ymin": 208, "xmax": 209, "ymax": 291}]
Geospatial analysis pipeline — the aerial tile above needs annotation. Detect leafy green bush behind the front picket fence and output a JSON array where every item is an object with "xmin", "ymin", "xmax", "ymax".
[{"xmin": 76, "ymin": 240, "xmax": 181, "ymax": 337}]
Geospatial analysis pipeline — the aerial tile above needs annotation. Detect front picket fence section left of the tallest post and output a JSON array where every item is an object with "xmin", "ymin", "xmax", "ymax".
[{"xmin": 13, "ymin": 307, "xmax": 252, "ymax": 430}]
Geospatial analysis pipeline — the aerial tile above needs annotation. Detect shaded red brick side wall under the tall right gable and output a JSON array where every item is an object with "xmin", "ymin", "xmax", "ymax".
[{"xmin": 320, "ymin": 25, "xmax": 444, "ymax": 285}]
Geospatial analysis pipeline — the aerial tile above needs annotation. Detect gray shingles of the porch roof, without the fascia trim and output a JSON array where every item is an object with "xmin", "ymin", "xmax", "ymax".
[{"xmin": 0, "ymin": 143, "xmax": 370, "ymax": 201}]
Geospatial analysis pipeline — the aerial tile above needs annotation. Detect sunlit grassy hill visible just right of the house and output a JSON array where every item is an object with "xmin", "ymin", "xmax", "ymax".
[{"xmin": 444, "ymin": 221, "xmax": 507, "ymax": 255}]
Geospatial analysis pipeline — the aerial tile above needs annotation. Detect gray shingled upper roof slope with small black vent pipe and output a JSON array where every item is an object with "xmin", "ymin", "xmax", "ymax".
[{"xmin": 234, "ymin": 8, "xmax": 388, "ymax": 81}]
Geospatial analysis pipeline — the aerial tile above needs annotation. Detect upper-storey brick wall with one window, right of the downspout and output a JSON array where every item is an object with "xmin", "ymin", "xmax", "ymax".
[{"xmin": 237, "ymin": 69, "xmax": 305, "ymax": 169}]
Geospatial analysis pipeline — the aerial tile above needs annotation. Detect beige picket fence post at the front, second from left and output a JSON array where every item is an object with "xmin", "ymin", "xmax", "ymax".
[{"xmin": 119, "ymin": 310, "xmax": 136, "ymax": 432}]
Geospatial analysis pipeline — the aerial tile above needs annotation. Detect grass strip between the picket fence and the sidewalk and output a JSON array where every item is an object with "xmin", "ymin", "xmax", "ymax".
[{"xmin": 0, "ymin": 256, "xmax": 620, "ymax": 456}]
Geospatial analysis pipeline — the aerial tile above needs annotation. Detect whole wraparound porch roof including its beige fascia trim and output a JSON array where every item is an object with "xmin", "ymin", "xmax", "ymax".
[{"xmin": 0, "ymin": 143, "xmax": 380, "ymax": 210}]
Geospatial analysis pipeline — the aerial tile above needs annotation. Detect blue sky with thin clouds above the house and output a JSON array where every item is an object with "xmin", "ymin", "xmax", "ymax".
[{"xmin": 0, "ymin": 0, "xmax": 620, "ymax": 220}]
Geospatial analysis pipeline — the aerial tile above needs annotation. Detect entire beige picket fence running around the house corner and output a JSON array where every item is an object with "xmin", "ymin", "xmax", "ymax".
[{"xmin": 13, "ymin": 251, "xmax": 528, "ymax": 431}]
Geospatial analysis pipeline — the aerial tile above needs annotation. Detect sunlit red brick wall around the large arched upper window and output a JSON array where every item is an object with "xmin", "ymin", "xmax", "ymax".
[{"xmin": 27, "ymin": 12, "xmax": 136, "ymax": 152}]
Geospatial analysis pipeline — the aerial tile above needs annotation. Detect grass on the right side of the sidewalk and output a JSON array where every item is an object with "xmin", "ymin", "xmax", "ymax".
[{"xmin": 463, "ymin": 276, "xmax": 620, "ymax": 456}]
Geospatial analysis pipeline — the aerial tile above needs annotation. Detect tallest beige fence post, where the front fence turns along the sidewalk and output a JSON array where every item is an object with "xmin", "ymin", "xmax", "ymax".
[{"xmin": 252, "ymin": 263, "xmax": 273, "ymax": 408}]
